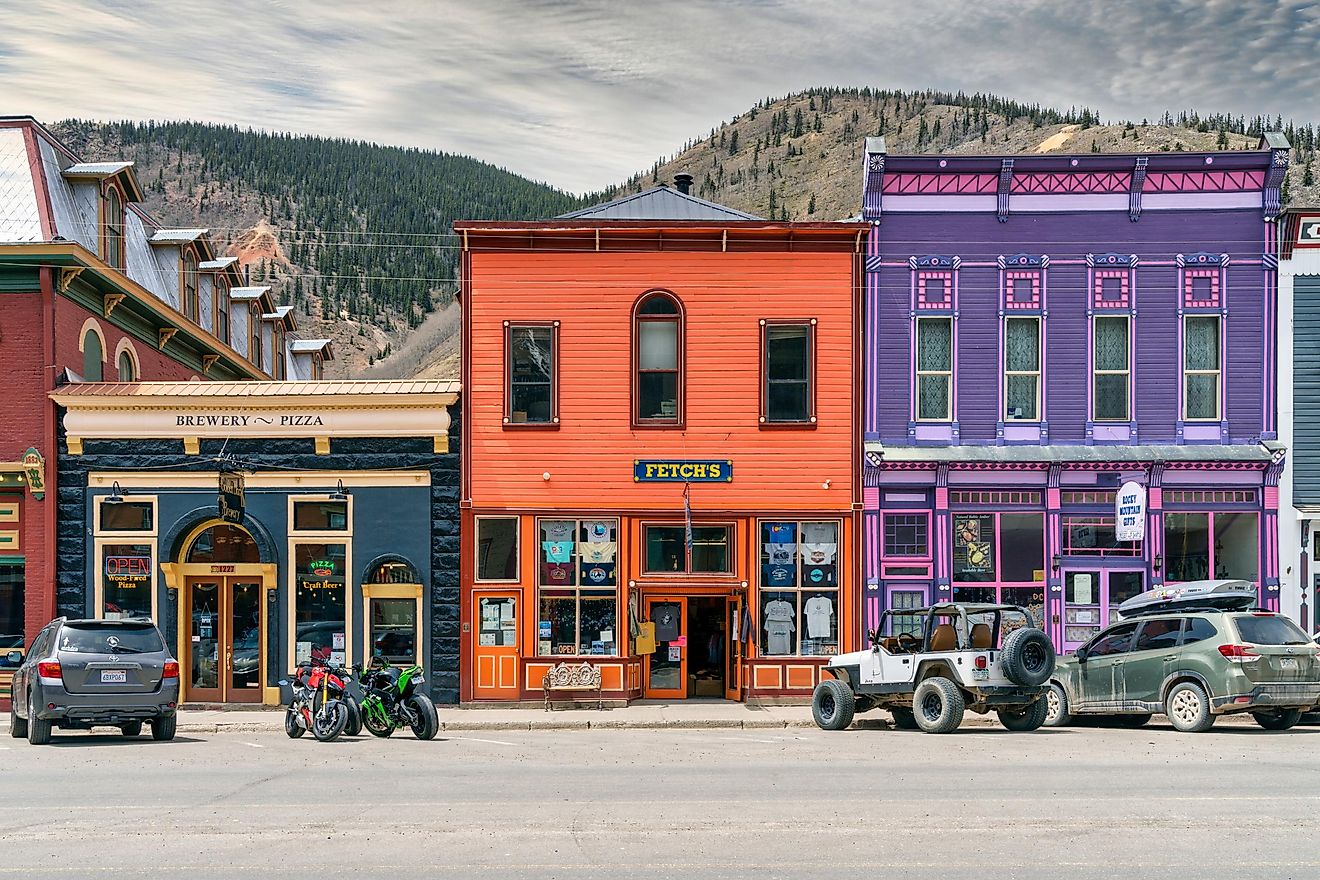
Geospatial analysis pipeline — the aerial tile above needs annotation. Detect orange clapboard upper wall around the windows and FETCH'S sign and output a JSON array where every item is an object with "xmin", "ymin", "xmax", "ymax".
[{"xmin": 463, "ymin": 249, "xmax": 854, "ymax": 515}]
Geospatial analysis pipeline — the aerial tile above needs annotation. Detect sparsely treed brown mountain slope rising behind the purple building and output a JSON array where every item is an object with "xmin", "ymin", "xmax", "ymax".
[{"xmin": 602, "ymin": 88, "xmax": 1320, "ymax": 220}]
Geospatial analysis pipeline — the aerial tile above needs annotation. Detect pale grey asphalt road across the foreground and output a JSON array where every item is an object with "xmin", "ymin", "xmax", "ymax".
[{"xmin": 0, "ymin": 724, "xmax": 1320, "ymax": 880}]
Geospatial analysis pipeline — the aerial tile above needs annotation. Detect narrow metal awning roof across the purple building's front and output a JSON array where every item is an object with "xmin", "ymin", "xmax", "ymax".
[{"xmin": 866, "ymin": 441, "xmax": 1283, "ymax": 464}]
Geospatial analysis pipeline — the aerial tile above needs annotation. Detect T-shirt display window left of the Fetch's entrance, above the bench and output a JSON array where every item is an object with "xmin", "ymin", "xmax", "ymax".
[{"xmin": 537, "ymin": 519, "xmax": 619, "ymax": 657}]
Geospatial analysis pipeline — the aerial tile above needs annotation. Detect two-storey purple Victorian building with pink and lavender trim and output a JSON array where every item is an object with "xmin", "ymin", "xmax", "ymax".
[{"xmin": 862, "ymin": 136, "xmax": 1288, "ymax": 649}]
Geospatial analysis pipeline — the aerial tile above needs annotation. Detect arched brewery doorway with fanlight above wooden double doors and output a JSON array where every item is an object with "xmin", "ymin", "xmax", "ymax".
[{"xmin": 180, "ymin": 522, "xmax": 267, "ymax": 703}]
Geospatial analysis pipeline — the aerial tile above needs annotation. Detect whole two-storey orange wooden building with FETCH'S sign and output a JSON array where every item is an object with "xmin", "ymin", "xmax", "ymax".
[{"xmin": 455, "ymin": 182, "xmax": 866, "ymax": 702}]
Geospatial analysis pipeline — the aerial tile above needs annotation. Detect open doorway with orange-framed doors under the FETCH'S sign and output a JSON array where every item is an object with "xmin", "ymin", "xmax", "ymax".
[{"xmin": 643, "ymin": 595, "xmax": 742, "ymax": 699}]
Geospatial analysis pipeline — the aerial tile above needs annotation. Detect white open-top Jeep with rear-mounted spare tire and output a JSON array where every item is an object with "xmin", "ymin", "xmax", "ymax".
[{"xmin": 812, "ymin": 602, "xmax": 1055, "ymax": 734}]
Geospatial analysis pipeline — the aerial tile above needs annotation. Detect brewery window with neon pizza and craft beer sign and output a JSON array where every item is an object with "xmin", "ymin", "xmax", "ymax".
[{"xmin": 293, "ymin": 542, "xmax": 348, "ymax": 665}]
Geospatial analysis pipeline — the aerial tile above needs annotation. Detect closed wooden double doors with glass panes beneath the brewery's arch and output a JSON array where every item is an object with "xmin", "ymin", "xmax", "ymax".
[{"xmin": 182, "ymin": 575, "xmax": 265, "ymax": 703}]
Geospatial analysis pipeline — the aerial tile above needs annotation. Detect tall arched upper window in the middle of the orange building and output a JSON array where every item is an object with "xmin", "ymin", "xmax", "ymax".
[{"xmin": 632, "ymin": 292, "xmax": 684, "ymax": 425}]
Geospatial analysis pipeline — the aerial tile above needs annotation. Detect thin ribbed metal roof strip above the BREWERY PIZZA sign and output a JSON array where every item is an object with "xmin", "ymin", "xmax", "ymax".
[{"xmin": 53, "ymin": 379, "xmax": 461, "ymax": 398}]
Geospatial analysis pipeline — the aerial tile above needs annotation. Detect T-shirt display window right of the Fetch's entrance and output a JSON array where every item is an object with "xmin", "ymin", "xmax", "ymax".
[{"xmin": 760, "ymin": 521, "xmax": 840, "ymax": 657}]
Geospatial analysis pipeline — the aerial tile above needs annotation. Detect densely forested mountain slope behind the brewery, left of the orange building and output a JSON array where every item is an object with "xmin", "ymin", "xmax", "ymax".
[{"xmin": 51, "ymin": 120, "xmax": 581, "ymax": 375}]
